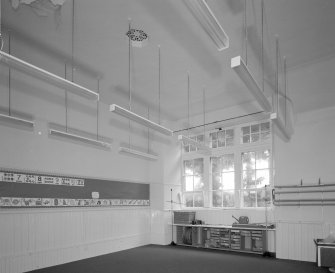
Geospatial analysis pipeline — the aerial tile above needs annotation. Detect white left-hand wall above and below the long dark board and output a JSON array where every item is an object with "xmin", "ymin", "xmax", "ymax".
[{"xmin": 0, "ymin": 11, "xmax": 170, "ymax": 273}]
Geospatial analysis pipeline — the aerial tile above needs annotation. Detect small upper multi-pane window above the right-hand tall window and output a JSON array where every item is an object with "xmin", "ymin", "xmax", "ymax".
[{"xmin": 241, "ymin": 122, "xmax": 270, "ymax": 143}]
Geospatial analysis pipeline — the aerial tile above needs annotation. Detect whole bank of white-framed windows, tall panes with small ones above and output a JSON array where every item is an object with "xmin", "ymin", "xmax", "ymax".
[{"xmin": 181, "ymin": 120, "xmax": 272, "ymax": 208}]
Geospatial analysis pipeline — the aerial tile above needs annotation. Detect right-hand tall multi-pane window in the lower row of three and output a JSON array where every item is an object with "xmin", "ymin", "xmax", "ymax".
[{"xmin": 241, "ymin": 150, "xmax": 270, "ymax": 207}]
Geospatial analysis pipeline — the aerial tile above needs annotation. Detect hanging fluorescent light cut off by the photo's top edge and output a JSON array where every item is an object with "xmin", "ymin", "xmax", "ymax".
[{"xmin": 184, "ymin": 0, "xmax": 229, "ymax": 51}]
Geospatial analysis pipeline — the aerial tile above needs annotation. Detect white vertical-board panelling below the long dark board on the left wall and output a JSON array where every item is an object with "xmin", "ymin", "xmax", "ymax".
[{"xmin": 0, "ymin": 208, "xmax": 150, "ymax": 273}]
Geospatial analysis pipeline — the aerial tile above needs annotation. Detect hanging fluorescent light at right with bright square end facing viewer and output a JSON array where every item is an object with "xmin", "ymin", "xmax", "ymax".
[{"xmin": 231, "ymin": 56, "xmax": 272, "ymax": 112}]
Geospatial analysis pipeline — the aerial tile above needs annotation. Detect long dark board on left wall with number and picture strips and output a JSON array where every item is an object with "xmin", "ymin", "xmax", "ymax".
[{"xmin": 0, "ymin": 169, "xmax": 150, "ymax": 207}]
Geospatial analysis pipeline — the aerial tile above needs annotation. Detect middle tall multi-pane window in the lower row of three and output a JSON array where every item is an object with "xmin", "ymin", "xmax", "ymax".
[{"xmin": 211, "ymin": 154, "xmax": 235, "ymax": 207}]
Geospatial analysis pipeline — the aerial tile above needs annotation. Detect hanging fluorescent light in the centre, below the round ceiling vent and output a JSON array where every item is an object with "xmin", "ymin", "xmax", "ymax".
[{"xmin": 109, "ymin": 104, "xmax": 173, "ymax": 136}]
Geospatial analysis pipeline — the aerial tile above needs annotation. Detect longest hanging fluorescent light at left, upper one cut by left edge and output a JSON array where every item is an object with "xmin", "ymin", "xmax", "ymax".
[{"xmin": 0, "ymin": 51, "xmax": 99, "ymax": 100}]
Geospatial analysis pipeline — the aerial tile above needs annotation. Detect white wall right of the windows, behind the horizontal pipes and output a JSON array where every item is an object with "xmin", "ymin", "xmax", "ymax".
[{"xmin": 274, "ymin": 105, "xmax": 335, "ymax": 261}]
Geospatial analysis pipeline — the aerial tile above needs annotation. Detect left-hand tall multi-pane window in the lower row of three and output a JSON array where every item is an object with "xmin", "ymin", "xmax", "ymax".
[{"xmin": 184, "ymin": 158, "xmax": 204, "ymax": 207}]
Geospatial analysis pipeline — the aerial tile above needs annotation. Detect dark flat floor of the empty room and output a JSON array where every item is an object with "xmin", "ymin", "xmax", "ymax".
[{"xmin": 27, "ymin": 245, "xmax": 329, "ymax": 273}]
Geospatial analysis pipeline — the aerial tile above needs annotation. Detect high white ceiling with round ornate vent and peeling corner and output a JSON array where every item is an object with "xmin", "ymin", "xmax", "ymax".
[{"xmin": 1, "ymin": 0, "xmax": 335, "ymax": 125}]
